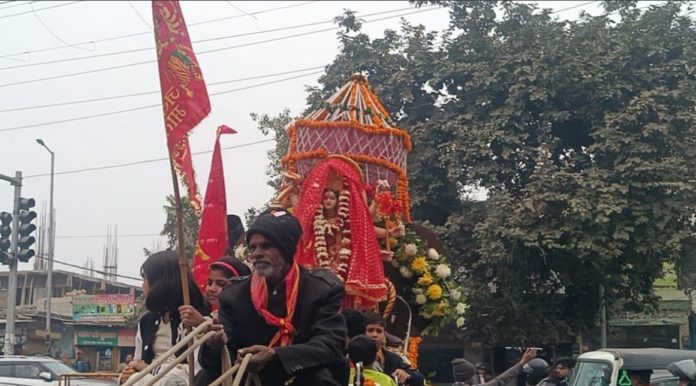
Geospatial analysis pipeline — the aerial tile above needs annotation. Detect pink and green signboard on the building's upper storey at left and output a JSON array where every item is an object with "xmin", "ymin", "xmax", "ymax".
[{"xmin": 72, "ymin": 294, "xmax": 135, "ymax": 322}]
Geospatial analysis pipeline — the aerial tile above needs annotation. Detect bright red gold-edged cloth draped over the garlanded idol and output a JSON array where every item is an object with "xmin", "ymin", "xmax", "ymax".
[{"xmin": 295, "ymin": 158, "xmax": 387, "ymax": 308}]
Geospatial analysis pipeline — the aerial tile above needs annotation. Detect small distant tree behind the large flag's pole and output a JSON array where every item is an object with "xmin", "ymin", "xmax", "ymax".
[{"xmin": 160, "ymin": 194, "xmax": 200, "ymax": 262}]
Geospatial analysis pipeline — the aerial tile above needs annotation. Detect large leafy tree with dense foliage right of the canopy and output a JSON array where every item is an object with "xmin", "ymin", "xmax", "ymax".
[{"xmin": 254, "ymin": 1, "xmax": 696, "ymax": 344}]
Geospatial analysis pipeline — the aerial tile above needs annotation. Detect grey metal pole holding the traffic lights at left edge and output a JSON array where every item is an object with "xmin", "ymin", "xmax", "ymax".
[{"xmin": 0, "ymin": 171, "xmax": 22, "ymax": 355}]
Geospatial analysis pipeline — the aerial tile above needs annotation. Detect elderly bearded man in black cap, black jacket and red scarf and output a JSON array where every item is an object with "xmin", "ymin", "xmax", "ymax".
[{"xmin": 196, "ymin": 211, "xmax": 348, "ymax": 386}]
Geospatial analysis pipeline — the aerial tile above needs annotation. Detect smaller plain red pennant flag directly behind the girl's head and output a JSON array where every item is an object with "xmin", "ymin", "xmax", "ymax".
[{"xmin": 193, "ymin": 125, "xmax": 236, "ymax": 293}]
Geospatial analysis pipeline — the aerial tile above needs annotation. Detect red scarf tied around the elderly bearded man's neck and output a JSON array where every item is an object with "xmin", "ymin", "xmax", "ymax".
[{"xmin": 251, "ymin": 262, "xmax": 300, "ymax": 347}]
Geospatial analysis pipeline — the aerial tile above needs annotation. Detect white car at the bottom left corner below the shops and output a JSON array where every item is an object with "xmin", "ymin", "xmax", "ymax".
[{"xmin": 0, "ymin": 355, "xmax": 117, "ymax": 386}]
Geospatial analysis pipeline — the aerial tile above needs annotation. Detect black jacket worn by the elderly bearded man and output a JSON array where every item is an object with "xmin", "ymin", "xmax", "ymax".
[{"xmin": 200, "ymin": 268, "xmax": 348, "ymax": 386}]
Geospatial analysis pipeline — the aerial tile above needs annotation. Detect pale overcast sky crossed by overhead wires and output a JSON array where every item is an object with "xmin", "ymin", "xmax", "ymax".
[{"xmin": 0, "ymin": 1, "xmax": 656, "ymax": 284}]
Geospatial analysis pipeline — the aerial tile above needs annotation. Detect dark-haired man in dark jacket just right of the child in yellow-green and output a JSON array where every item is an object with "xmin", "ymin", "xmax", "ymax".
[{"xmin": 365, "ymin": 312, "xmax": 424, "ymax": 386}]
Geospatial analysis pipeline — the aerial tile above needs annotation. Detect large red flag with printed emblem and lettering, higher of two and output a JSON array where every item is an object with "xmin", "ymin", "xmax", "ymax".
[{"xmin": 152, "ymin": 1, "xmax": 210, "ymax": 210}]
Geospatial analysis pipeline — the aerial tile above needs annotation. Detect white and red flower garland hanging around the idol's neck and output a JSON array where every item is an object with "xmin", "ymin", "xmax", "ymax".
[{"xmin": 312, "ymin": 187, "xmax": 351, "ymax": 278}]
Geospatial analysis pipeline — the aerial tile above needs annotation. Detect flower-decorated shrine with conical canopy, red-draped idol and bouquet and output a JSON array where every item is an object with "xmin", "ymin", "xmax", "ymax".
[{"xmin": 271, "ymin": 74, "xmax": 465, "ymax": 339}]
